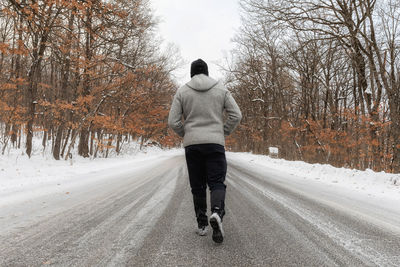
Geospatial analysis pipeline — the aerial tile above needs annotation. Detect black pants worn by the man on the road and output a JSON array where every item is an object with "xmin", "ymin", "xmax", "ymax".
[{"xmin": 185, "ymin": 144, "xmax": 227, "ymax": 226}]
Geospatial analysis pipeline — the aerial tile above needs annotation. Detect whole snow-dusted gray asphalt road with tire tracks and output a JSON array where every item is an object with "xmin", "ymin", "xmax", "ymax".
[{"xmin": 0, "ymin": 155, "xmax": 400, "ymax": 266}]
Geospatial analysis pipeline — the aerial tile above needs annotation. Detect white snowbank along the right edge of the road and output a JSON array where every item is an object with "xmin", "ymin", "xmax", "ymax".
[{"xmin": 227, "ymin": 153, "xmax": 400, "ymax": 200}]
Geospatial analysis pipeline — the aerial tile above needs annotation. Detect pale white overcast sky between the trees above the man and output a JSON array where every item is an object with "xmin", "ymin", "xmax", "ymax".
[{"xmin": 150, "ymin": 0, "xmax": 240, "ymax": 85}]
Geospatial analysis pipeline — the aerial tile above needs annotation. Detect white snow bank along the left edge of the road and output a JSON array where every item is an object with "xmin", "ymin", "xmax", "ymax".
[{"xmin": 0, "ymin": 145, "xmax": 182, "ymax": 204}]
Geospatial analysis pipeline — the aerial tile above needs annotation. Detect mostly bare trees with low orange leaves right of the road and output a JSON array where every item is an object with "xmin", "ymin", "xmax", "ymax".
[{"xmin": 225, "ymin": 0, "xmax": 400, "ymax": 173}]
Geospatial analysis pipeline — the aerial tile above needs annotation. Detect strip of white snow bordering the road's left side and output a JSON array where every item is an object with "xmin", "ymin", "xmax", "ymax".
[{"xmin": 0, "ymin": 144, "xmax": 182, "ymax": 196}]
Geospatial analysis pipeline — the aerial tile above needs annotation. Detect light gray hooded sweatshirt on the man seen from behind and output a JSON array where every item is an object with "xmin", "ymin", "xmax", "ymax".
[{"xmin": 168, "ymin": 74, "xmax": 242, "ymax": 147}]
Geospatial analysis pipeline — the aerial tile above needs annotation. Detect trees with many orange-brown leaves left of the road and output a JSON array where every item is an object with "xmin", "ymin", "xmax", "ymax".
[{"xmin": 0, "ymin": 0, "xmax": 176, "ymax": 159}]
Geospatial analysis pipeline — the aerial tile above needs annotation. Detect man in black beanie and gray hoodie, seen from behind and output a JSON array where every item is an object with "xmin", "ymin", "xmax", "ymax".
[{"xmin": 168, "ymin": 59, "xmax": 242, "ymax": 243}]
